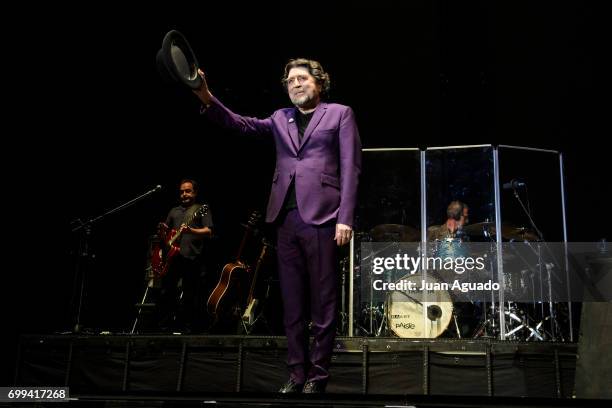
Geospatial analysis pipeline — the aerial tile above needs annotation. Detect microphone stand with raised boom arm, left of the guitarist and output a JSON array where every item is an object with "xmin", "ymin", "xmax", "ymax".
[{"xmin": 70, "ymin": 185, "xmax": 162, "ymax": 333}]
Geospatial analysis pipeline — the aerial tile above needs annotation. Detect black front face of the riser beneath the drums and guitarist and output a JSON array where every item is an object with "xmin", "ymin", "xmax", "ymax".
[{"xmin": 15, "ymin": 335, "xmax": 577, "ymax": 399}]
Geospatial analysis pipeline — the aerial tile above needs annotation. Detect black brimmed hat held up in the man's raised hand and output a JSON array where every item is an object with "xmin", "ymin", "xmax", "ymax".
[{"xmin": 156, "ymin": 30, "xmax": 202, "ymax": 89}]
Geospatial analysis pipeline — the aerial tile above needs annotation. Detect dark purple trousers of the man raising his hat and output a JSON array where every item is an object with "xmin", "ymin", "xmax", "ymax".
[{"xmin": 277, "ymin": 209, "xmax": 338, "ymax": 384}]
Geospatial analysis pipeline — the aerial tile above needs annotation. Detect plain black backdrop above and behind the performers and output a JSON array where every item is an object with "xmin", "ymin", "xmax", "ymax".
[{"xmin": 2, "ymin": 0, "xmax": 611, "ymax": 383}]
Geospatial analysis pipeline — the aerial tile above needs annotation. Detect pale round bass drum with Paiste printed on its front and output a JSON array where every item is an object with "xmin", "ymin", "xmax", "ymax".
[{"xmin": 387, "ymin": 274, "xmax": 453, "ymax": 338}]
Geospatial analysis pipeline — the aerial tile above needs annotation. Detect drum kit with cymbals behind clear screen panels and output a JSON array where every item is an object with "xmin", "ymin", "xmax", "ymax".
[{"xmin": 357, "ymin": 222, "xmax": 555, "ymax": 341}]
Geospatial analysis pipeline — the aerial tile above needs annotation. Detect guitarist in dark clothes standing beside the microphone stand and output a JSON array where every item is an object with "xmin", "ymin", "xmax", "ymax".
[{"xmin": 159, "ymin": 179, "xmax": 213, "ymax": 333}]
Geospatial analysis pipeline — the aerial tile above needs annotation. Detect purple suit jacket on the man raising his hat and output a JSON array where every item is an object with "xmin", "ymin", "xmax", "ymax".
[{"xmin": 205, "ymin": 97, "xmax": 361, "ymax": 226}]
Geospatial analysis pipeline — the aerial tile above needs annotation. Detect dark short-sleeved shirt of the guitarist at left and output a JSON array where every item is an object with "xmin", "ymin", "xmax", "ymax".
[{"xmin": 166, "ymin": 204, "xmax": 213, "ymax": 259}]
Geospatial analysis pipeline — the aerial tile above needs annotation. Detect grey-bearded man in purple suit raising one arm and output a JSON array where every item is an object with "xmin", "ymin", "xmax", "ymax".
[{"xmin": 194, "ymin": 58, "xmax": 361, "ymax": 393}]
